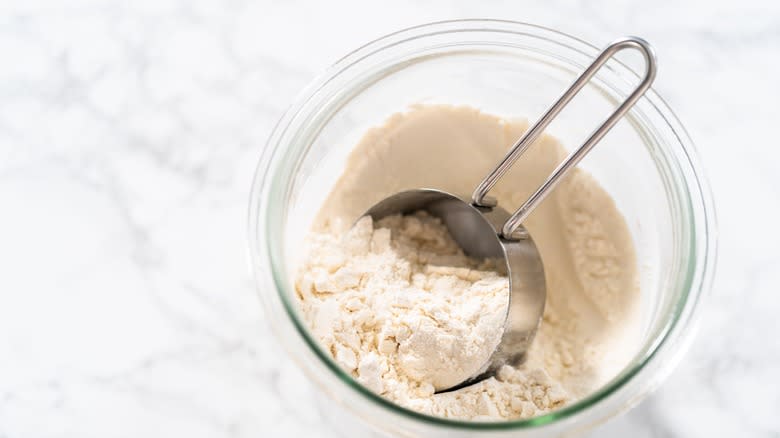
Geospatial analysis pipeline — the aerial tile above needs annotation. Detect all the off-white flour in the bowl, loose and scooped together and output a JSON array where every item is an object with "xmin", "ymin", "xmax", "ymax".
[{"xmin": 296, "ymin": 106, "xmax": 639, "ymax": 420}]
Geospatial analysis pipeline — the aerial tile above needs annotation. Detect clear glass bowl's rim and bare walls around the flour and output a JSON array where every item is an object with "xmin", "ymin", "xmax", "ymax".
[{"xmin": 249, "ymin": 20, "xmax": 716, "ymax": 437}]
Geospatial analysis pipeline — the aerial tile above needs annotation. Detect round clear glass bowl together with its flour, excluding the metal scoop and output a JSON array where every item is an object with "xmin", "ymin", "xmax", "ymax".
[{"xmin": 250, "ymin": 20, "xmax": 715, "ymax": 436}]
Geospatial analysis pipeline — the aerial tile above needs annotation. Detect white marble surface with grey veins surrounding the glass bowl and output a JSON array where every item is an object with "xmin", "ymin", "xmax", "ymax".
[{"xmin": 0, "ymin": 0, "xmax": 780, "ymax": 438}]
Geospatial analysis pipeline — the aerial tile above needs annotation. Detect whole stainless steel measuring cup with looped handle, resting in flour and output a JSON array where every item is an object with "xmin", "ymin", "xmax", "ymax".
[{"xmin": 365, "ymin": 37, "xmax": 656, "ymax": 392}]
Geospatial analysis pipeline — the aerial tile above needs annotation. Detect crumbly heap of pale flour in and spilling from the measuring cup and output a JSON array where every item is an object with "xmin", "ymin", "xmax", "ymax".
[{"xmin": 297, "ymin": 212, "xmax": 509, "ymax": 392}]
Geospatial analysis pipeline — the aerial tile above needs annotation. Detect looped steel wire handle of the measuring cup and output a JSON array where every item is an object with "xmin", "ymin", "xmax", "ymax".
[{"xmin": 471, "ymin": 37, "xmax": 656, "ymax": 240}]
